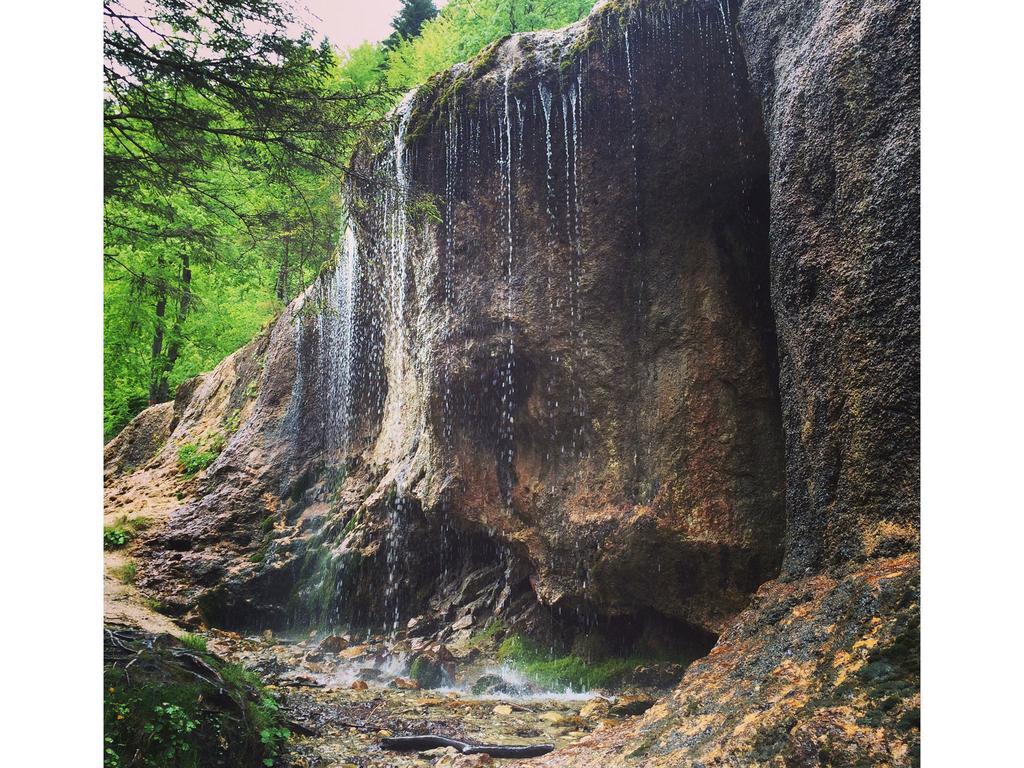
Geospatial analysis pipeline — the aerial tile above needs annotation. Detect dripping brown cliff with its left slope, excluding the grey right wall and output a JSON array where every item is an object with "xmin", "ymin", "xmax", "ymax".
[{"xmin": 110, "ymin": 2, "xmax": 783, "ymax": 651}]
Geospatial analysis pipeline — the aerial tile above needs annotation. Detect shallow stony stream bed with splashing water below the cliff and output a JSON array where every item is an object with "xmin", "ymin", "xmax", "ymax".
[{"xmin": 208, "ymin": 630, "xmax": 655, "ymax": 768}]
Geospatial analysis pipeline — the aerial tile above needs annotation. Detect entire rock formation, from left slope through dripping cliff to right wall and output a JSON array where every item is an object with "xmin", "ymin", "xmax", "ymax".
[{"xmin": 108, "ymin": 0, "xmax": 920, "ymax": 766}]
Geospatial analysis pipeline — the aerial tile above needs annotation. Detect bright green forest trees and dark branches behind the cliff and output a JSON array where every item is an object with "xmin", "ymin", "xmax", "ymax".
[{"xmin": 103, "ymin": 0, "xmax": 594, "ymax": 440}]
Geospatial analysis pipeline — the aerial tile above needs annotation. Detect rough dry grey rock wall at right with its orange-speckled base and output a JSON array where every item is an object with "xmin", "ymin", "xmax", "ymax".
[{"xmin": 539, "ymin": 0, "xmax": 921, "ymax": 768}]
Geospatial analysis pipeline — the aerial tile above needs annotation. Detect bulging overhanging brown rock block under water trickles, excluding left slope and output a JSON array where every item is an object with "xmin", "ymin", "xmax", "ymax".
[{"xmin": 339, "ymin": 4, "xmax": 782, "ymax": 632}]
